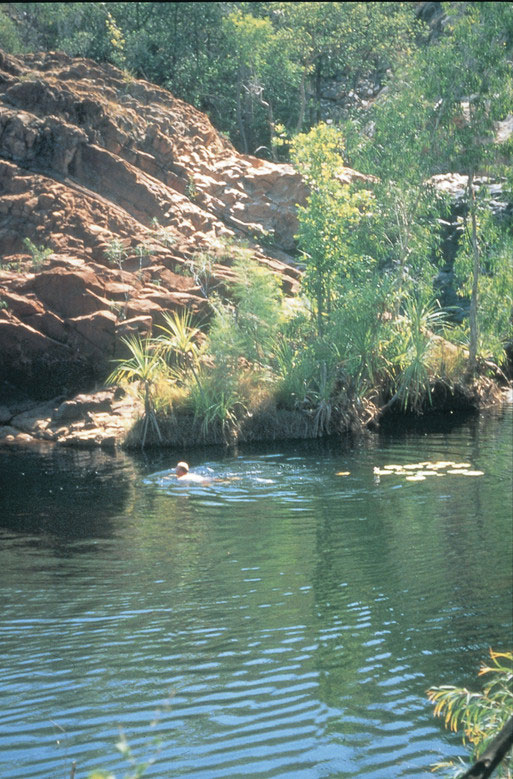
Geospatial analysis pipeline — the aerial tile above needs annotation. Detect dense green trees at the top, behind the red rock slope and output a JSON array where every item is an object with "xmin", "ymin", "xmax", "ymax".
[{"xmin": 8, "ymin": 2, "xmax": 417, "ymax": 158}]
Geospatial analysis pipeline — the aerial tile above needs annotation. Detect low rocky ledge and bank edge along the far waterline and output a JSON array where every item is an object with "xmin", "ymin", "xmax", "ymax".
[{"xmin": 0, "ymin": 379, "xmax": 513, "ymax": 451}]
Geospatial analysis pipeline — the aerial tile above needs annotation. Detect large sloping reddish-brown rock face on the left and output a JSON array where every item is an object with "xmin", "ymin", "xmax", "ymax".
[{"xmin": 0, "ymin": 52, "xmax": 360, "ymax": 391}]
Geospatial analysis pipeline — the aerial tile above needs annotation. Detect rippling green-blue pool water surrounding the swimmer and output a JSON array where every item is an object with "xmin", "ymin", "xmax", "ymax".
[{"xmin": 0, "ymin": 406, "xmax": 513, "ymax": 779}]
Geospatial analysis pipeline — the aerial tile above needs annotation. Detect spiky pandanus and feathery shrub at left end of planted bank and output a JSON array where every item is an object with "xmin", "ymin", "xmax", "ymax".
[{"xmin": 108, "ymin": 253, "xmax": 283, "ymax": 446}]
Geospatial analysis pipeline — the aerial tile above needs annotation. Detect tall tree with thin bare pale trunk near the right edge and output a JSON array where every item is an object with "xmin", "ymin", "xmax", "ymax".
[{"xmin": 412, "ymin": 2, "xmax": 513, "ymax": 376}]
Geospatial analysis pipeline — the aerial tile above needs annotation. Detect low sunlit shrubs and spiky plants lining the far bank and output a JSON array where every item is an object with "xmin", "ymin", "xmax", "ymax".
[{"xmin": 105, "ymin": 222, "xmax": 499, "ymax": 446}]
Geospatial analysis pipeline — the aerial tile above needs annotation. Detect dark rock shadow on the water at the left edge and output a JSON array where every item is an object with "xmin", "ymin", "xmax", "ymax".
[{"xmin": 0, "ymin": 447, "xmax": 135, "ymax": 541}]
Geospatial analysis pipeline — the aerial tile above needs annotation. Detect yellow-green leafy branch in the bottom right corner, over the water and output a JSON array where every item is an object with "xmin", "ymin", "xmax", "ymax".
[{"xmin": 427, "ymin": 649, "xmax": 513, "ymax": 779}]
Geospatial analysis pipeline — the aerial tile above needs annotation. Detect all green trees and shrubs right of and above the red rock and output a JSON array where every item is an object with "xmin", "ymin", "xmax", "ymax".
[{"xmin": 4, "ymin": 2, "xmax": 513, "ymax": 445}]
